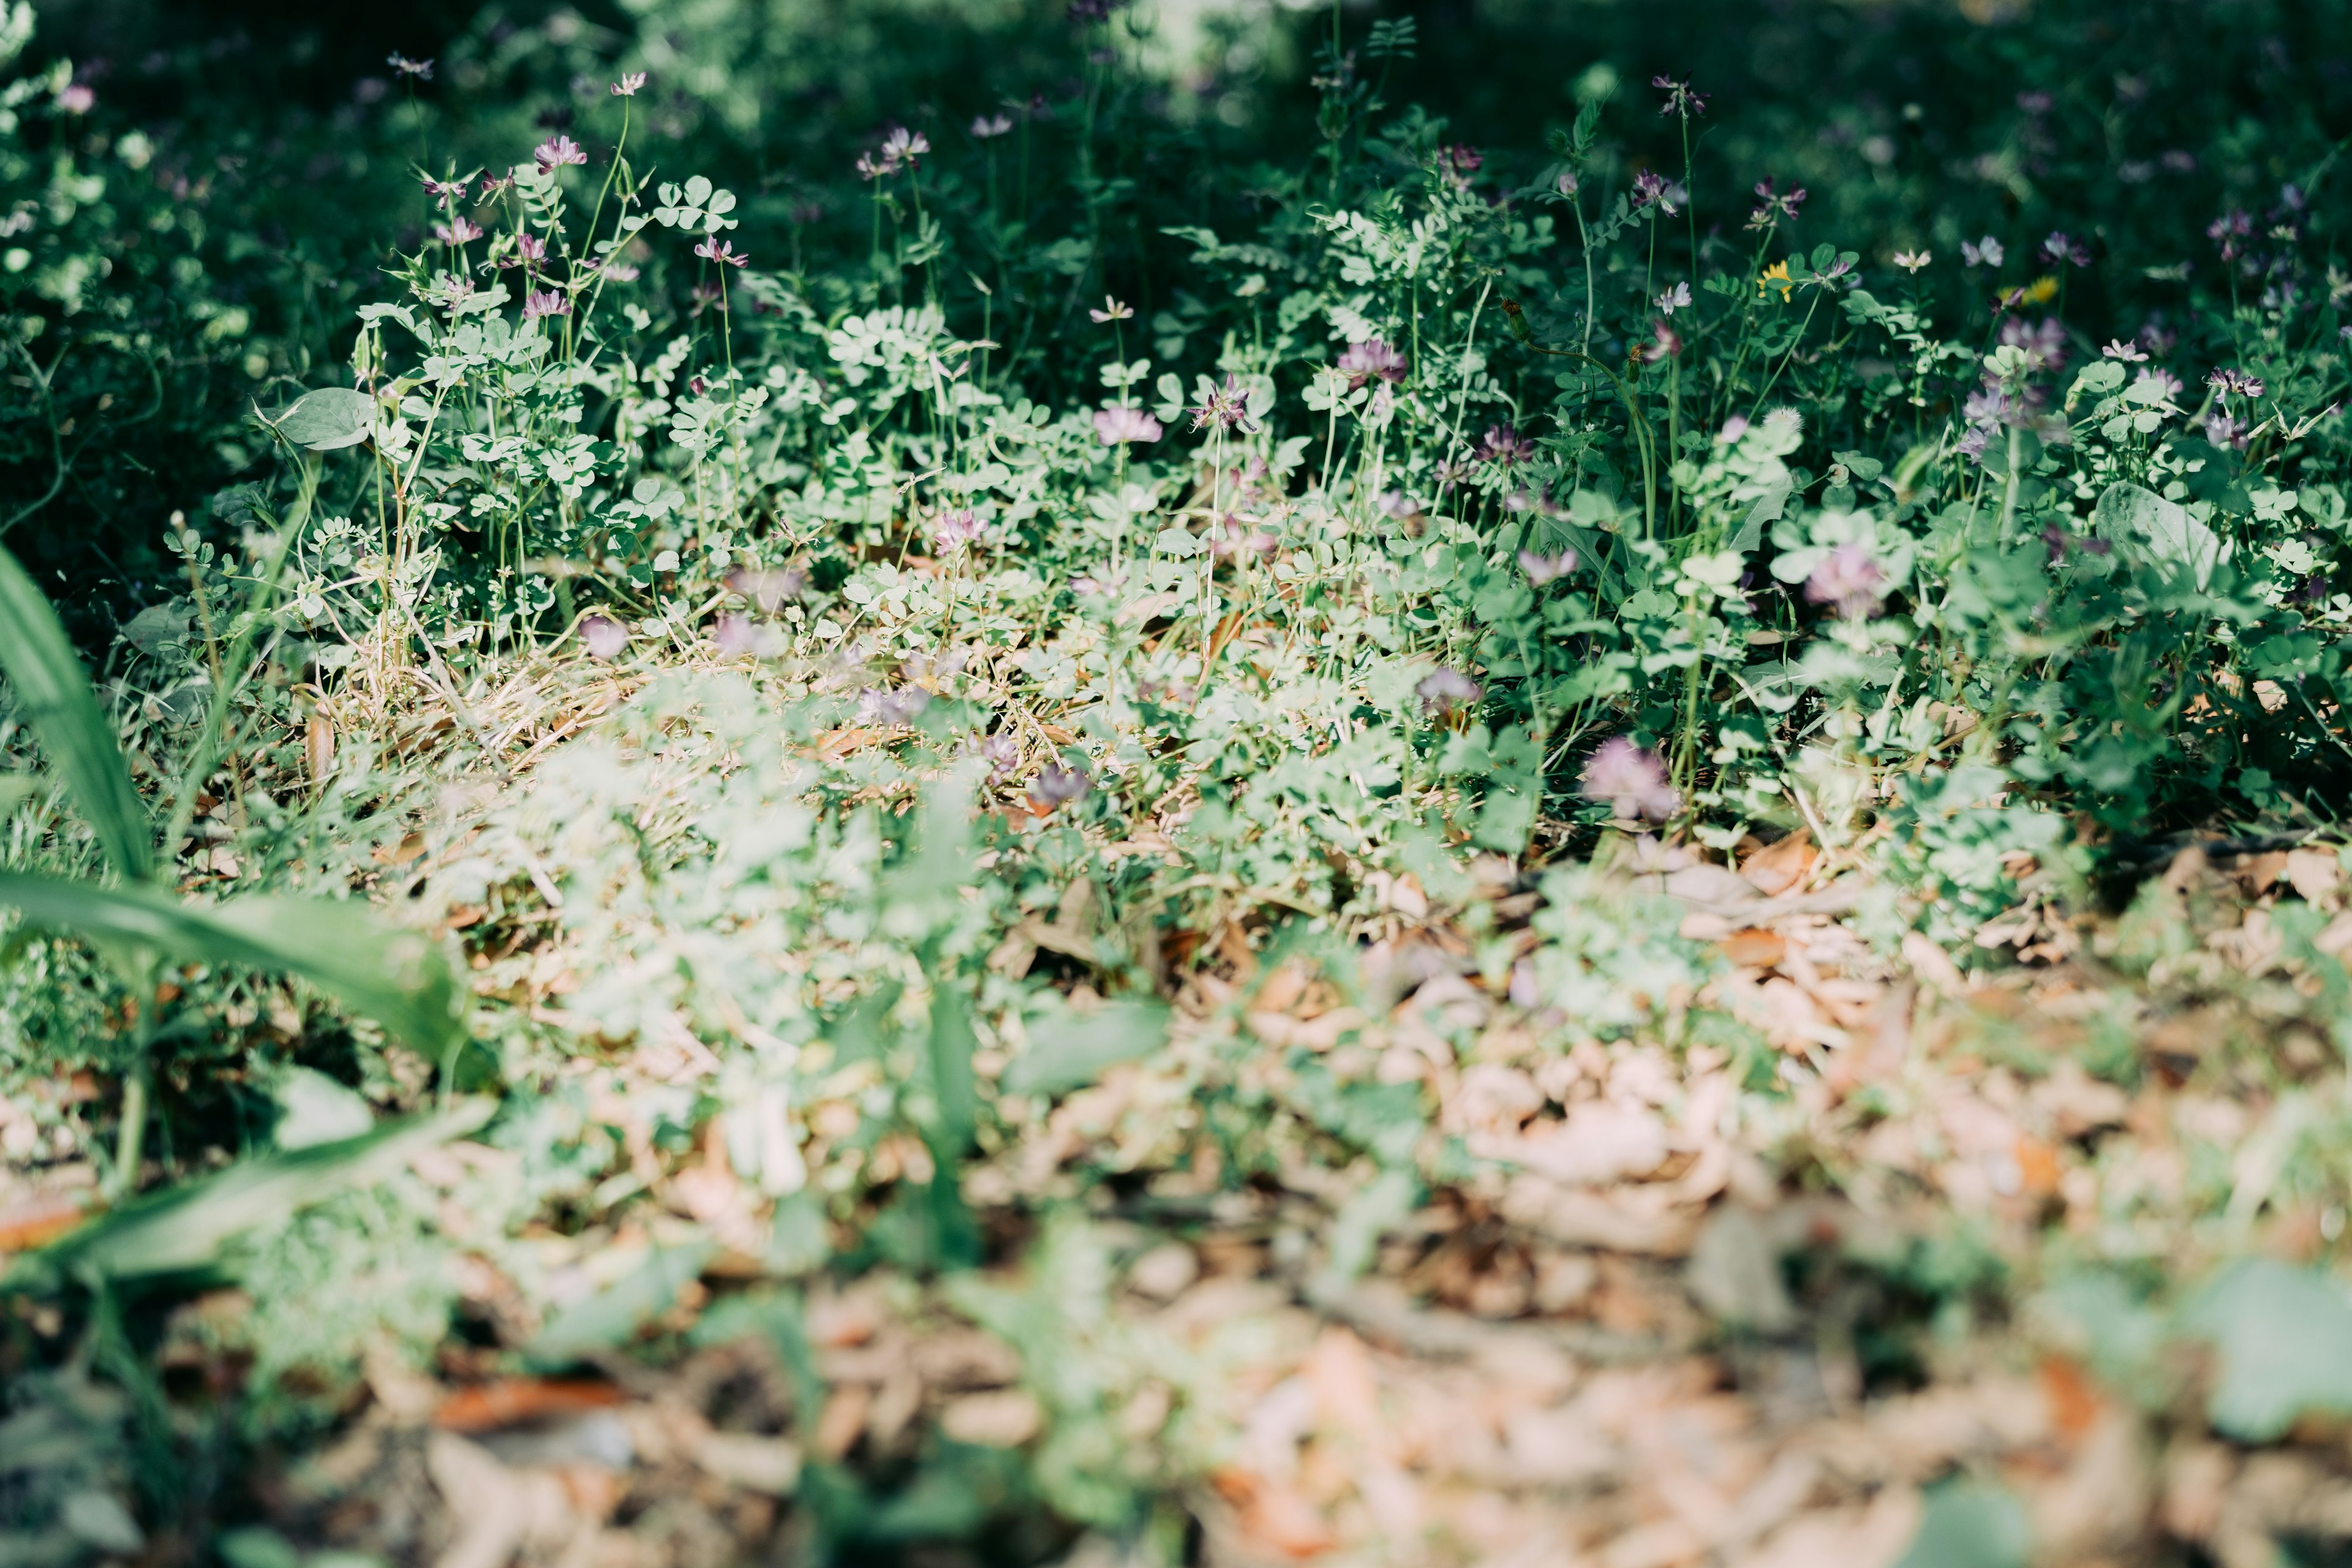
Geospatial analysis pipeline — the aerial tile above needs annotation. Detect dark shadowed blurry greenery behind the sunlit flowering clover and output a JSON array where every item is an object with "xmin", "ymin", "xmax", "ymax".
[{"xmin": 0, "ymin": 0, "xmax": 2352, "ymax": 635}]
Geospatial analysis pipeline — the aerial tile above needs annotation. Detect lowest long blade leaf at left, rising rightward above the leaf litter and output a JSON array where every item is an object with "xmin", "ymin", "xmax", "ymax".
[{"xmin": 9, "ymin": 1100, "xmax": 496, "ymax": 1281}]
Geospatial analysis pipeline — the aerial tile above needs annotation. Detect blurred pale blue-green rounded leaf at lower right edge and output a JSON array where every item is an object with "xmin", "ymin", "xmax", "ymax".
[{"xmin": 2180, "ymin": 1257, "xmax": 2352, "ymax": 1444}]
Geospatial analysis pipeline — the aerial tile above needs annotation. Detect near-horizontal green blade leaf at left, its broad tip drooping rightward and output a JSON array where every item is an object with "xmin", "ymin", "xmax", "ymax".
[{"xmin": 0, "ymin": 872, "xmax": 463, "ymax": 1055}]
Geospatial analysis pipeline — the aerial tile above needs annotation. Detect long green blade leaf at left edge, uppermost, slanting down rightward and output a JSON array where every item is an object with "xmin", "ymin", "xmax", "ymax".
[{"xmin": 0, "ymin": 550, "xmax": 155, "ymax": 881}]
